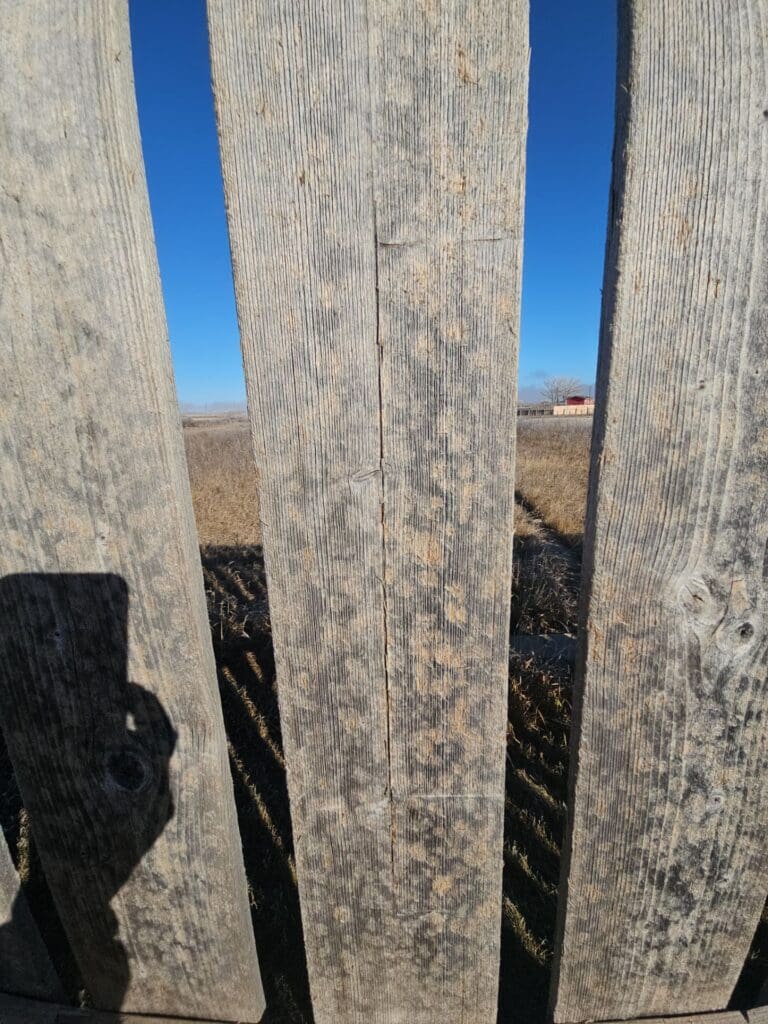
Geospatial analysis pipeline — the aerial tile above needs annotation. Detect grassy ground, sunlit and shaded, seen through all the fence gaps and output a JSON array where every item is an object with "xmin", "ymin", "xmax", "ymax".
[{"xmin": 0, "ymin": 411, "xmax": 768, "ymax": 1024}]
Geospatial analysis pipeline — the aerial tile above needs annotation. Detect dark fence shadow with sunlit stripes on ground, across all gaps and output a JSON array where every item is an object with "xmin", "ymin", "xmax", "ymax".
[{"xmin": 0, "ymin": 536, "xmax": 768, "ymax": 1024}]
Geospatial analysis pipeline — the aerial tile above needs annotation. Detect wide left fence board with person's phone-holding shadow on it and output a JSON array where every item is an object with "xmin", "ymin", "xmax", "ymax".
[{"xmin": 0, "ymin": 0, "xmax": 263, "ymax": 1021}]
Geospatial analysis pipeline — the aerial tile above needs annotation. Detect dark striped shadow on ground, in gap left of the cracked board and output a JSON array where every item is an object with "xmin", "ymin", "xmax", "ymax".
[{"xmin": 203, "ymin": 548, "xmax": 312, "ymax": 1024}]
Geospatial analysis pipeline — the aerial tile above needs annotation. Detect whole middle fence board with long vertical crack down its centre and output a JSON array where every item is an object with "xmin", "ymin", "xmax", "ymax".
[{"xmin": 209, "ymin": 0, "xmax": 528, "ymax": 1024}]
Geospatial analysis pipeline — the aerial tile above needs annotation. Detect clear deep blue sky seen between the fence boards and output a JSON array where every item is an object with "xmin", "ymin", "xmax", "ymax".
[{"xmin": 130, "ymin": 0, "xmax": 616, "ymax": 404}]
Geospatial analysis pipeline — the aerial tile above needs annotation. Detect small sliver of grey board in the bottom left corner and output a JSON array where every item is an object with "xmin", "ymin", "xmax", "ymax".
[{"xmin": 0, "ymin": 834, "xmax": 63, "ymax": 999}]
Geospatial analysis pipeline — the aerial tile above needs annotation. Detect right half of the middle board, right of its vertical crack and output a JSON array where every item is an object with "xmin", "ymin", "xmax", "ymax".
[{"xmin": 370, "ymin": 0, "xmax": 528, "ymax": 1021}]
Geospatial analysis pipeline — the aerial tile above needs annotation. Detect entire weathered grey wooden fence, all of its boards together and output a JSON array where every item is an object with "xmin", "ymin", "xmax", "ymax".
[{"xmin": 0, "ymin": 0, "xmax": 768, "ymax": 1024}]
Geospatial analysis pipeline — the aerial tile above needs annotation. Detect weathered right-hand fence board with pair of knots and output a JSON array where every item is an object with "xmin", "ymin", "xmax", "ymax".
[{"xmin": 554, "ymin": 0, "xmax": 768, "ymax": 1021}]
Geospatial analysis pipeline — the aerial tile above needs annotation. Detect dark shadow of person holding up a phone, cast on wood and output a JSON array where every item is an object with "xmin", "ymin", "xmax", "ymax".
[{"xmin": 0, "ymin": 573, "xmax": 176, "ymax": 1008}]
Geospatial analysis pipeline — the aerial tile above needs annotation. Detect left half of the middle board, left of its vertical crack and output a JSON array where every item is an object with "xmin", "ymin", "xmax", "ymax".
[{"xmin": 208, "ymin": 0, "xmax": 387, "ymax": 1024}]
